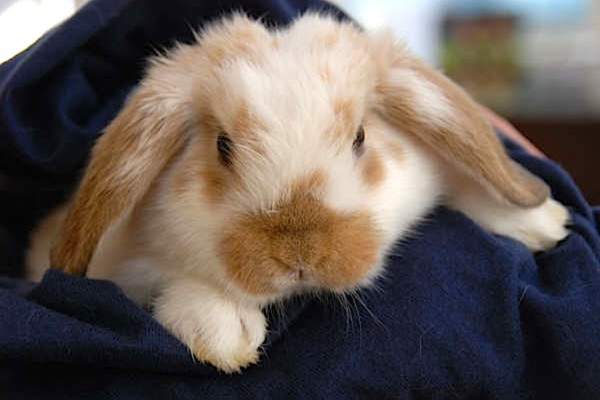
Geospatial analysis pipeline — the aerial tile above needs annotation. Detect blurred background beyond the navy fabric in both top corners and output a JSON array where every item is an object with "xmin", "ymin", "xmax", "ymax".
[{"xmin": 0, "ymin": 0, "xmax": 600, "ymax": 204}]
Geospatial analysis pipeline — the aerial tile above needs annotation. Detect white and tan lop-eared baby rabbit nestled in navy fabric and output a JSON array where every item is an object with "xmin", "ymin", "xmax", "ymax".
[{"xmin": 28, "ymin": 12, "xmax": 569, "ymax": 373}]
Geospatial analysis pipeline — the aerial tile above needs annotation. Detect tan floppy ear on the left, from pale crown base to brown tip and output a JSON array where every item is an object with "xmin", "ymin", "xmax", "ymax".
[{"xmin": 50, "ymin": 13, "xmax": 272, "ymax": 275}]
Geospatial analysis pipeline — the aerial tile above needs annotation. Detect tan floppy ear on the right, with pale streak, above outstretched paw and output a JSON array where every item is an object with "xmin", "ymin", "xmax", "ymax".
[{"xmin": 375, "ymin": 38, "xmax": 549, "ymax": 207}]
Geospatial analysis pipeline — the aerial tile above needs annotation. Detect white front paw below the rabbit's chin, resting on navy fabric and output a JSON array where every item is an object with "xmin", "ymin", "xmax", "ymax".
[{"xmin": 155, "ymin": 282, "xmax": 267, "ymax": 373}]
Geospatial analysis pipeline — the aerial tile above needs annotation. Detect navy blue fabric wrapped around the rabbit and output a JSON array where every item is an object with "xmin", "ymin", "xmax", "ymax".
[{"xmin": 0, "ymin": 0, "xmax": 600, "ymax": 399}]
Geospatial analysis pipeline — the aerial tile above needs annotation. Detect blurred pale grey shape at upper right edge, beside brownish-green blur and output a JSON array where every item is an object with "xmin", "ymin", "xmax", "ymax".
[{"xmin": 514, "ymin": 0, "xmax": 600, "ymax": 120}]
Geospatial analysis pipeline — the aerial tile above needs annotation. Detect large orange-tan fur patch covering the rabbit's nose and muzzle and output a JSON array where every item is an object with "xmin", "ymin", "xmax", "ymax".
[{"xmin": 220, "ymin": 173, "xmax": 379, "ymax": 295}]
